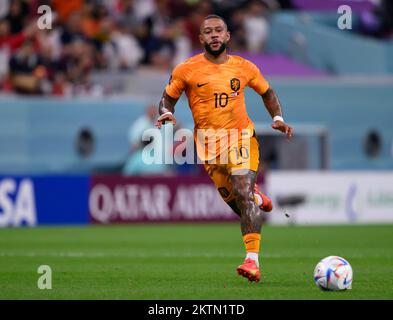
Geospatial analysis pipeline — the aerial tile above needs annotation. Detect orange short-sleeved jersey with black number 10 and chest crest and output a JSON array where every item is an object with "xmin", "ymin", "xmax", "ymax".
[{"xmin": 165, "ymin": 53, "xmax": 269, "ymax": 159}]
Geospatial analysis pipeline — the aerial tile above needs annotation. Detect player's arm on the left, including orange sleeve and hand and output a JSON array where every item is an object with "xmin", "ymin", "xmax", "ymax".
[{"xmin": 156, "ymin": 63, "xmax": 186, "ymax": 128}]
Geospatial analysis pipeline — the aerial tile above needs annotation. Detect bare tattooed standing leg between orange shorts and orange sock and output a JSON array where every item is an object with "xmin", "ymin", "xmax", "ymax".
[{"xmin": 231, "ymin": 170, "xmax": 264, "ymax": 235}]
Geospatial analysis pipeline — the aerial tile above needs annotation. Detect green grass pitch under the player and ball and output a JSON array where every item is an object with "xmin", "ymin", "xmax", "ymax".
[{"xmin": 0, "ymin": 223, "xmax": 393, "ymax": 300}]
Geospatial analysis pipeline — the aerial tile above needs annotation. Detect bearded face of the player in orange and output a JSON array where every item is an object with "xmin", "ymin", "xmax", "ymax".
[{"xmin": 199, "ymin": 19, "xmax": 230, "ymax": 56}]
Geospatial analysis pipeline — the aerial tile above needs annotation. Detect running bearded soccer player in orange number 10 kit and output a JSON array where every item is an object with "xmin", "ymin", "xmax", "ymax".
[{"xmin": 156, "ymin": 15, "xmax": 292, "ymax": 281}]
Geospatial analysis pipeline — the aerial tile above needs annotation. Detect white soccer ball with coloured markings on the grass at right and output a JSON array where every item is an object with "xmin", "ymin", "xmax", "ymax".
[{"xmin": 314, "ymin": 256, "xmax": 353, "ymax": 291}]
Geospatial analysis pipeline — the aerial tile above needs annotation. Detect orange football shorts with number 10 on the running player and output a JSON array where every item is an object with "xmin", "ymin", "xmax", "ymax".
[{"xmin": 204, "ymin": 135, "xmax": 259, "ymax": 202}]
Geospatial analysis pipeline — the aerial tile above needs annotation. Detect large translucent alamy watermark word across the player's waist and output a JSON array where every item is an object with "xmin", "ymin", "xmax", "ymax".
[{"xmin": 142, "ymin": 124, "xmax": 253, "ymax": 168}]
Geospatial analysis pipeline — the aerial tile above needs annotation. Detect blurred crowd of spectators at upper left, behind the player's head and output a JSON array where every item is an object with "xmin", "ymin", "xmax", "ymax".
[{"xmin": 0, "ymin": 0, "xmax": 287, "ymax": 96}]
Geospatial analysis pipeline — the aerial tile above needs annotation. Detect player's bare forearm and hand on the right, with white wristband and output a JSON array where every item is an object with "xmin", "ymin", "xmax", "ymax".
[{"xmin": 261, "ymin": 87, "xmax": 292, "ymax": 139}]
